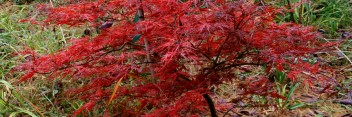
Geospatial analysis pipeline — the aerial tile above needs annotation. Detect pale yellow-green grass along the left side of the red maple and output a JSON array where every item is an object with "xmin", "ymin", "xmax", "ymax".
[{"xmin": 0, "ymin": 2, "xmax": 81, "ymax": 116}]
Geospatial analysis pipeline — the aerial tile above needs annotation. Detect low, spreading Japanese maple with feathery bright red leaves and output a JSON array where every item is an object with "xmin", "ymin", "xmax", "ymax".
[{"xmin": 16, "ymin": 0, "xmax": 328, "ymax": 116}]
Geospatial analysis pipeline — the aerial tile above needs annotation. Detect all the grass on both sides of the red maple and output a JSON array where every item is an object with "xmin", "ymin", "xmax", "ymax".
[{"xmin": 0, "ymin": 0, "xmax": 352, "ymax": 117}]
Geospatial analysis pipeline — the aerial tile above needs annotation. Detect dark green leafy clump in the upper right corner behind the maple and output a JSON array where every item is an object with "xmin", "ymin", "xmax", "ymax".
[{"xmin": 276, "ymin": 0, "xmax": 352, "ymax": 36}]
